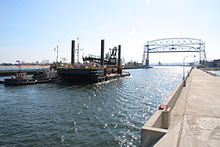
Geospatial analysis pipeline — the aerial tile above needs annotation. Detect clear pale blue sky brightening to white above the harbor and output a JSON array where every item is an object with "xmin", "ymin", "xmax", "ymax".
[{"xmin": 0, "ymin": 0, "xmax": 220, "ymax": 63}]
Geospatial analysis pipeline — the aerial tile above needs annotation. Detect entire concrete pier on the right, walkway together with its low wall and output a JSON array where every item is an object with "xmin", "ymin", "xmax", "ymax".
[{"xmin": 141, "ymin": 69, "xmax": 220, "ymax": 147}]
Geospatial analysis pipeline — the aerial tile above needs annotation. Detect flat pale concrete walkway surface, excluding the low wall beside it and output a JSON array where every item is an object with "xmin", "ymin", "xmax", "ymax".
[{"xmin": 155, "ymin": 69, "xmax": 220, "ymax": 147}]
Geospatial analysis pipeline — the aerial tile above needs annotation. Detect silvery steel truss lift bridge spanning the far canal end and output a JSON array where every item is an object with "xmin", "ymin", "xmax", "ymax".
[{"xmin": 142, "ymin": 38, "xmax": 206, "ymax": 67}]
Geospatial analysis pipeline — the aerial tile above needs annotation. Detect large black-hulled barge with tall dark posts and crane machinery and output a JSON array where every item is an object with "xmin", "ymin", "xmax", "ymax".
[{"xmin": 57, "ymin": 40, "xmax": 125, "ymax": 84}]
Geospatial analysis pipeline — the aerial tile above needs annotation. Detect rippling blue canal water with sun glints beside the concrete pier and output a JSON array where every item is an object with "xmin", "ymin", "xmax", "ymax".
[{"xmin": 0, "ymin": 67, "xmax": 188, "ymax": 146}]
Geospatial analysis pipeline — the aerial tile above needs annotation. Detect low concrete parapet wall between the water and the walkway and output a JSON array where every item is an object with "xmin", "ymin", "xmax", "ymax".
[{"xmin": 141, "ymin": 68, "xmax": 193, "ymax": 147}]
